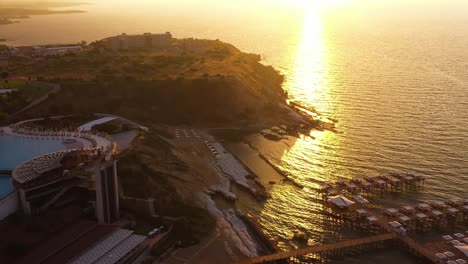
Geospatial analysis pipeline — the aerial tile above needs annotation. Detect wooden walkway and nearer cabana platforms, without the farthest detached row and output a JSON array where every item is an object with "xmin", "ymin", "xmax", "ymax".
[{"xmin": 237, "ymin": 194, "xmax": 468, "ymax": 264}]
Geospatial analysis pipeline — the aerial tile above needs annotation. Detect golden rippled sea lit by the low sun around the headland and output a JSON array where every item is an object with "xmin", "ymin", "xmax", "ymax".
[{"xmin": 0, "ymin": 0, "xmax": 468, "ymax": 264}]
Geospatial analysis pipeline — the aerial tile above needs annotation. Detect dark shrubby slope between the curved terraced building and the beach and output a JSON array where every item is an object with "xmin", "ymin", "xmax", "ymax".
[{"xmin": 118, "ymin": 132, "xmax": 215, "ymax": 244}]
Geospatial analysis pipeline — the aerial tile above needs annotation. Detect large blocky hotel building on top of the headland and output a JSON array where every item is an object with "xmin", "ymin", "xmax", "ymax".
[{"xmin": 104, "ymin": 32, "xmax": 172, "ymax": 51}]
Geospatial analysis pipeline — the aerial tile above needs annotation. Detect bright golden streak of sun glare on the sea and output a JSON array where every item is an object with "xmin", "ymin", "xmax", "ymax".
[{"xmin": 261, "ymin": 5, "xmax": 339, "ymax": 248}]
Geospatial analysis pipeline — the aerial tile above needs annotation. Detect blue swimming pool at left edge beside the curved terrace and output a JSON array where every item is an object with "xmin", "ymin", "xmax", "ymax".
[{"xmin": 0, "ymin": 135, "xmax": 65, "ymax": 198}]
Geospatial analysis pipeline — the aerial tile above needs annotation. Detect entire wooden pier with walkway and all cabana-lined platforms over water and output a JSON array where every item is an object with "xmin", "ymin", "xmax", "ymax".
[{"xmin": 237, "ymin": 173, "xmax": 468, "ymax": 264}]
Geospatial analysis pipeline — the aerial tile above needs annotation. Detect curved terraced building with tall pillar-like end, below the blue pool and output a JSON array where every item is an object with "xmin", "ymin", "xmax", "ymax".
[{"xmin": 12, "ymin": 148, "xmax": 119, "ymax": 223}]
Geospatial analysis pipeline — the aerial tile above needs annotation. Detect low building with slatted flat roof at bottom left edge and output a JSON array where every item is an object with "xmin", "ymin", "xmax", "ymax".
[{"xmin": 15, "ymin": 220, "xmax": 146, "ymax": 264}]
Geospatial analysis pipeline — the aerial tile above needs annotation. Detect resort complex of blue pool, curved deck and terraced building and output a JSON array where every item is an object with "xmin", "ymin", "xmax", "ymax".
[{"xmin": 0, "ymin": 115, "xmax": 143, "ymax": 223}]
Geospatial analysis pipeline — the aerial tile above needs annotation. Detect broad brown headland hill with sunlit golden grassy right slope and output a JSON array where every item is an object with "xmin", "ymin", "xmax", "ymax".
[{"xmin": 13, "ymin": 39, "xmax": 314, "ymax": 126}]
